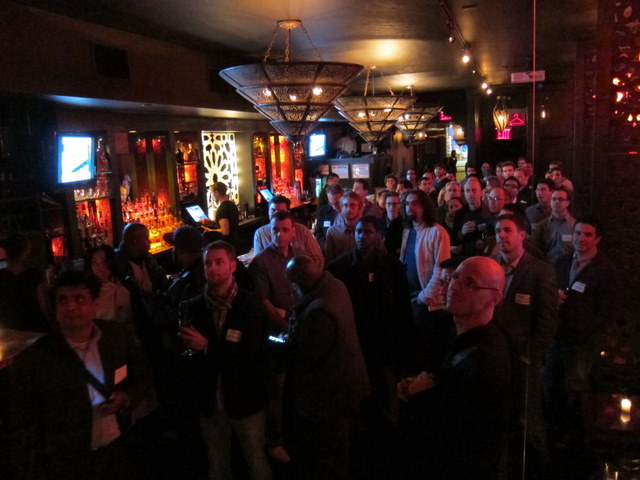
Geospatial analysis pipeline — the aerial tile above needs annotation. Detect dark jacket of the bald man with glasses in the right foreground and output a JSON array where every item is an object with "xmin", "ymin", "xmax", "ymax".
[{"xmin": 410, "ymin": 322, "xmax": 511, "ymax": 480}]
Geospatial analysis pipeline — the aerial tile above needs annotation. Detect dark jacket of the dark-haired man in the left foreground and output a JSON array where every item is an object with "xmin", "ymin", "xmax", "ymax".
[{"xmin": 3, "ymin": 320, "xmax": 144, "ymax": 480}]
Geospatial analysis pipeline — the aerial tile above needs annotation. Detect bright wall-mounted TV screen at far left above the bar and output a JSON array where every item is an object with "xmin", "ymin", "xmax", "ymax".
[{"xmin": 58, "ymin": 134, "xmax": 96, "ymax": 184}]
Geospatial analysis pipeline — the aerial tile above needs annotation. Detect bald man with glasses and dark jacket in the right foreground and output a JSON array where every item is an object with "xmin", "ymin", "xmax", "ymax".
[{"xmin": 398, "ymin": 257, "xmax": 511, "ymax": 480}]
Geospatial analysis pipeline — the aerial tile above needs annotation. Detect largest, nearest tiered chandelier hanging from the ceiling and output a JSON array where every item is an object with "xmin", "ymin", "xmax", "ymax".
[{"xmin": 220, "ymin": 20, "xmax": 363, "ymax": 140}]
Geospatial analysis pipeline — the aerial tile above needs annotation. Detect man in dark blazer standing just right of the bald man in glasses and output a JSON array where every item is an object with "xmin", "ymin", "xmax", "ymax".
[{"xmin": 495, "ymin": 214, "xmax": 558, "ymax": 478}]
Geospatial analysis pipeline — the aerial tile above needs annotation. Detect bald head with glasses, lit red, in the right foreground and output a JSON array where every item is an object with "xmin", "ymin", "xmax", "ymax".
[{"xmin": 446, "ymin": 257, "xmax": 505, "ymax": 334}]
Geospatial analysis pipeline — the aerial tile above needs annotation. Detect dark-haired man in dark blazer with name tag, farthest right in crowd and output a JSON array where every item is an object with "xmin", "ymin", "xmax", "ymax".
[{"xmin": 544, "ymin": 217, "xmax": 620, "ymax": 437}]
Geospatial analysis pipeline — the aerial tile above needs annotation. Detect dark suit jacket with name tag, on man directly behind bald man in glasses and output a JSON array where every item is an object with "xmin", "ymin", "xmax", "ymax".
[{"xmin": 494, "ymin": 252, "xmax": 558, "ymax": 365}]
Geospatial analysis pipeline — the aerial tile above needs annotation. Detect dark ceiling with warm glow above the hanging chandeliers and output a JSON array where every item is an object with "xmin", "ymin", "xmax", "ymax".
[{"xmin": 11, "ymin": 0, "xmax": 597, "ymax": 93}]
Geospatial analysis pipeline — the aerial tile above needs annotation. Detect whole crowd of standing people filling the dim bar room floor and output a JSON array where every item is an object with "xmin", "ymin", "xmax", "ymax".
[{"xmin": 0, "ymin": 158, "xmax": 618, "ymax": 480}]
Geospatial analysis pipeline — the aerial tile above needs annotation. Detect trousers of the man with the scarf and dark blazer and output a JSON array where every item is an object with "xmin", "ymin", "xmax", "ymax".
[{"xmin": 200, "ymin": 410, "xmax": 271, "ymax": 480}]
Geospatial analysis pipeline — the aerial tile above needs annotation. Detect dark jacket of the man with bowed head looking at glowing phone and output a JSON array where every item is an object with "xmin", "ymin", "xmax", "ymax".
[{"xmin": 285, "ymin": 272, "xmax": 370, "ymax": 418}]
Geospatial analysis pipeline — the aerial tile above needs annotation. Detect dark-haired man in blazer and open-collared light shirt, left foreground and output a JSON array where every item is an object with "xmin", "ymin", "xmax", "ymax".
[{"xmin": 3, "ymin": 272, "xmax": 148, "ymax": 480}]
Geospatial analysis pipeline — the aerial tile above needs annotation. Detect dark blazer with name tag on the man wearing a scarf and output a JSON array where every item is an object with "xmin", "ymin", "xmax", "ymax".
[{"xmin": 188, "ymin": 289, "xmax": 266, "ymax": 418}]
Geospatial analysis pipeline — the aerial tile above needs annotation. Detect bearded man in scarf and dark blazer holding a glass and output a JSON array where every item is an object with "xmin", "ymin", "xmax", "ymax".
[{"xmin": 180, "ymin": 240, "xmax": 271, "ymax": 480}]
